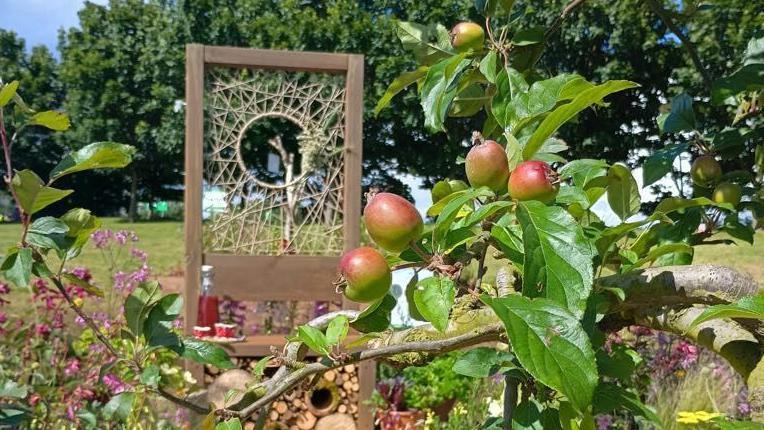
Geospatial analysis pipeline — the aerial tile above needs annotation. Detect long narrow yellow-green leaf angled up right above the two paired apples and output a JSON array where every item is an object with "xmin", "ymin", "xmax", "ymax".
[{"xmin": 523, "ymin": 81, "xmax": 638, "ymax": 160}]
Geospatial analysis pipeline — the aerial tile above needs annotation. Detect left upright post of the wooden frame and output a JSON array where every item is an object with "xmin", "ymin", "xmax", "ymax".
[{"xmin": 183, "ymin": 44, "xmax": 204, "ymax": 383}]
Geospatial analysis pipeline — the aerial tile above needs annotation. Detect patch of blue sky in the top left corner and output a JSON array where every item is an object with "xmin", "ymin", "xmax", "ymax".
[{"xmin": 0, "ymin": 0, "xmax": 106, "ymax": 56}]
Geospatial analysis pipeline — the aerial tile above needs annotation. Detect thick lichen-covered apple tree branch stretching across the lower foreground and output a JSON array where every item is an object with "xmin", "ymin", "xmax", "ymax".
[{"xmin": 210, "ymin": 265, "xmax": 764, "ymax": 418}]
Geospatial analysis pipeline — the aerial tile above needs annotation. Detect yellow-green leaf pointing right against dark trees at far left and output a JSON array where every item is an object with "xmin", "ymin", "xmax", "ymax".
[{"xmin": 50, "ymin": 142, "xmax": 135, "ymax": 181}]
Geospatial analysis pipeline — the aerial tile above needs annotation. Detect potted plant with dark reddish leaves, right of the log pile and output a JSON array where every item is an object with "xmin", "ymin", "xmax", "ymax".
[{"xmin": 375, "ymin": 376, "xmax": 425, "ymax": 430}]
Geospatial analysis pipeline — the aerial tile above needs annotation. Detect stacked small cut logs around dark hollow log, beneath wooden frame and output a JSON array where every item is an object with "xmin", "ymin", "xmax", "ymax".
[{"xmin": 206, "ymin": 359, "xmax": 361, "ymax": 430}]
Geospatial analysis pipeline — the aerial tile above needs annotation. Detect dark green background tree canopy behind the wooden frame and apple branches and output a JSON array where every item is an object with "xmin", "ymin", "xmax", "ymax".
[{"xmin": 0, "ymin": 0, "xmax": 764, "ymax": 213}]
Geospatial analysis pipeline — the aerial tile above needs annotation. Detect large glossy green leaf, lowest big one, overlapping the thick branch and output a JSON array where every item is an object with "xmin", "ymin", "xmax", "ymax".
[{"xmin": 482, "ymin": 295, "xmax": 598, "ymax": 411}]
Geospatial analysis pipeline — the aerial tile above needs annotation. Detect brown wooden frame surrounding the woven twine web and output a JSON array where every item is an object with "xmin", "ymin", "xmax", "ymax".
[{"xmin": 184, "ymin": 44, "xmax": 368, "ymax": 429}]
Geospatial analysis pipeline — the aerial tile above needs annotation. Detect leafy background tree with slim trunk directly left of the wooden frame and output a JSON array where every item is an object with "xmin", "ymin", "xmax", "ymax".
[{"xmin": 60, "ymin": 0, "xmax": 184, "ymax": 220}]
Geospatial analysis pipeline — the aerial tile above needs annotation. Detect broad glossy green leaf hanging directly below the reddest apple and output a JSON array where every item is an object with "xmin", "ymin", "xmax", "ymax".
[{"xmin": 517, "ymin": 201, "xmax": 594, "ymax": 317}]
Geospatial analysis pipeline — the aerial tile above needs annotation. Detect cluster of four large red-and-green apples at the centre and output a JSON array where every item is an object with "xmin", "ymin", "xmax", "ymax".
[{"xmin": 339, "ymin": 139, "xmax": 559, "ymax": 303}]
